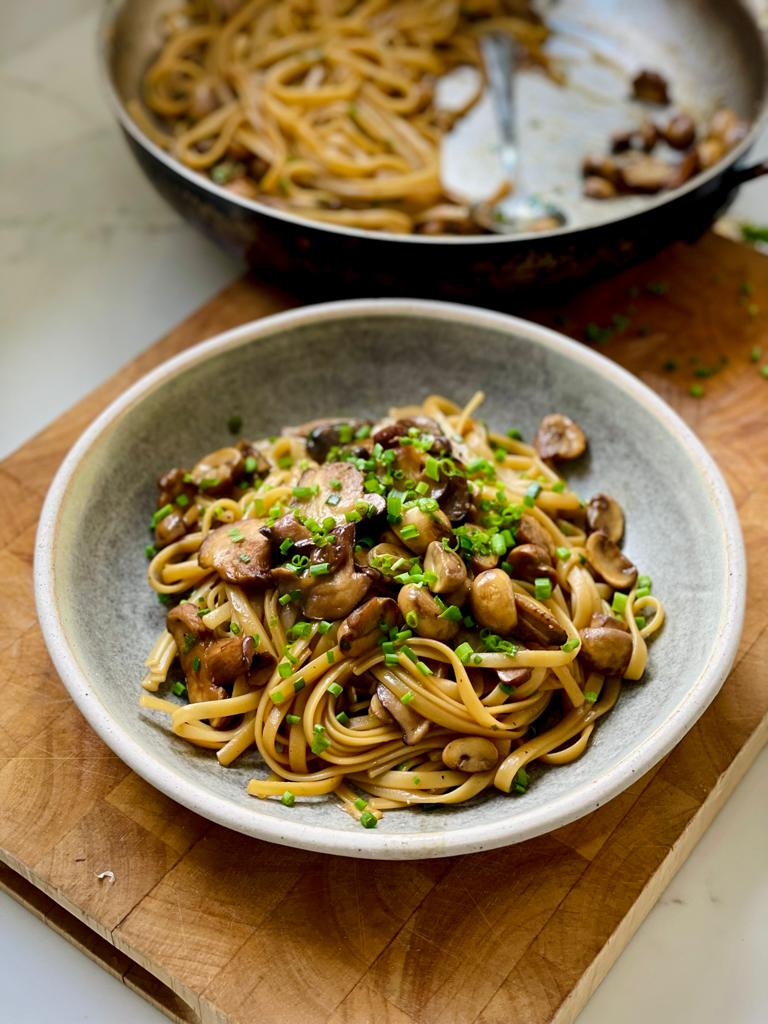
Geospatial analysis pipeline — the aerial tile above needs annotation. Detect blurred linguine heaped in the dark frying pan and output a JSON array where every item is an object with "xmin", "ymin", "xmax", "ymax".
[{"xmin": 128, "ymin": 0, "xmax": 547, "ymax": 233}]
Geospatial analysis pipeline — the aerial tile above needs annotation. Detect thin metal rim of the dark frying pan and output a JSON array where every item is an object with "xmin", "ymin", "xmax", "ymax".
[{"xmin": 97, "ymin": 0, "xmax": 768, "ymax": 247}]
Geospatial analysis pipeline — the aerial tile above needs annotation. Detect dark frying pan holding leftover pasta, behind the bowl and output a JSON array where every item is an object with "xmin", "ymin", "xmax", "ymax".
[{"xmin": 100, "ymin": 0, "xmax": 768, "ymax": 305}]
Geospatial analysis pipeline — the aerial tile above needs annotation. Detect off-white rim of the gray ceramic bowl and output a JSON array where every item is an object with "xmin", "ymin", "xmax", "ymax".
[{"xmin": 34, "ymin": 299, "xmax": 746, "ymax": 860}]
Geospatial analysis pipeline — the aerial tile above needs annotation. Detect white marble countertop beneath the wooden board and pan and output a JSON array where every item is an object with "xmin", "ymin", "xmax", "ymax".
[{"xmin": 0, "ymin": 0, "xmax": 768, "ymax": 1024}]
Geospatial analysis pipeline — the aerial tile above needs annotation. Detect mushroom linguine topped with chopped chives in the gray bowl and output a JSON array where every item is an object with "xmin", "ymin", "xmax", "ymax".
[{"xmin": 141, "ymin": 393, "xmax": 664, "ymax": 827}]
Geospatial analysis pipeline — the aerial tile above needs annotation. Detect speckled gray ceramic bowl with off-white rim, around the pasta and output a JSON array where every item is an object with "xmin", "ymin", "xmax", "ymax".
[{"xmin": 35, "ymin": 300, "xmax": 745, "ymax": 858}]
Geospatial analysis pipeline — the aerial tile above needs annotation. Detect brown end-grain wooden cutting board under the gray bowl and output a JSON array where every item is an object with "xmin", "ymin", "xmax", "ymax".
[{"xmin": 0, "ymin": 236, "xmax": 768, "ymax": 1024}]
